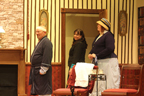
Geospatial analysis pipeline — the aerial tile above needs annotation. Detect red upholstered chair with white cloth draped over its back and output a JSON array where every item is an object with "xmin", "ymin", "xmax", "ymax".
[{"xmin": 53, "ymin": 66, "xmax": 98, "ymax": 96}]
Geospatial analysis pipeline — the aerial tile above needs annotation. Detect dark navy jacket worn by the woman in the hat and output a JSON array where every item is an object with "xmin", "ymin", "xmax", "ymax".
[{"xmin": 90, "ymin": 31, "xmax": 117, "ymax": 59}]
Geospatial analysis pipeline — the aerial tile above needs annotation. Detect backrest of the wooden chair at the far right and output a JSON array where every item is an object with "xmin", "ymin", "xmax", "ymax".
[{"xmin": 120, "ymin": 64, "xmax": 143, "ymax": 89}]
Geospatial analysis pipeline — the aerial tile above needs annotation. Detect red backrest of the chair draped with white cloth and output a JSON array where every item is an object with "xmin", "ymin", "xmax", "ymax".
[{"xmin": 67, "ymin": 65, "xmax": 98, "ymax": 93}]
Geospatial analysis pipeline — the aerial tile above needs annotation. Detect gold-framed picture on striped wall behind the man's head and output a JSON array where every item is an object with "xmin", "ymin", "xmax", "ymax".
[{"xmin": 39, "ymin": 9, "xmax": 49, "ymax": 34}]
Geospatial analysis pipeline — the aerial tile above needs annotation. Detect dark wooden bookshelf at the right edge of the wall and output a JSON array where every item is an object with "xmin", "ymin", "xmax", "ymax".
[{"xmin": 138, "ymin": 7, "xmax": 144, "ymax": 64}]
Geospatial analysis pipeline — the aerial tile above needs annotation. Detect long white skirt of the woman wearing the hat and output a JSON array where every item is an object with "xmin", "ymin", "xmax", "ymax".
[{"xmin": 89, "ymin": 58, "xmax": 120, "ymax": 96}]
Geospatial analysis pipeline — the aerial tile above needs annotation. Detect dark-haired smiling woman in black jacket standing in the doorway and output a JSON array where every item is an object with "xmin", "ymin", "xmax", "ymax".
[{"xmin": 68, "ymin": 29, "xmax": 87, "ymax": 73}]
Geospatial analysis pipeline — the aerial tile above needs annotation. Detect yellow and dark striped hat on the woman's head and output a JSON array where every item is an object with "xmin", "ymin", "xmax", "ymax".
[{"xmin": 96, "ymin": 18, "xmax": 111, "ymax": 30}]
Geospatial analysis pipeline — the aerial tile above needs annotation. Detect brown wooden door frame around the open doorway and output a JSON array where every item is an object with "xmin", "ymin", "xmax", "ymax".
[{"xmin": 60, "ymin": 8, "xmax": 107, "ymax": 87}]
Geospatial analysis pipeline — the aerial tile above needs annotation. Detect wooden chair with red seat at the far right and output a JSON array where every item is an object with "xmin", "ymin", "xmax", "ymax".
[{"xmin": 102, "ymin": 64, "xmax": 143, "ymax": 96}]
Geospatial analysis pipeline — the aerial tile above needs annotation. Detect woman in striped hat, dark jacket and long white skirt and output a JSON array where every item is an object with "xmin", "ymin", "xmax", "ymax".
[{"xmin": 88, "ymin": 18, "xmax": 120, "ymax": 95}]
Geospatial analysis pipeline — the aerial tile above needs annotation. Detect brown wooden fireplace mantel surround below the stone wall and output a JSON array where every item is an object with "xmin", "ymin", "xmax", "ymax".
[{"xmin": 0, "ymin": 49, "xmax": 27, "ymax": 96}]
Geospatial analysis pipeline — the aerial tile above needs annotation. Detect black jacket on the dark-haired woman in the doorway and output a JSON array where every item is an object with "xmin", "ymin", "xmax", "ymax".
[{"xmin": 68, "ymin": 41, "xmax": 87, "ymax": 67}]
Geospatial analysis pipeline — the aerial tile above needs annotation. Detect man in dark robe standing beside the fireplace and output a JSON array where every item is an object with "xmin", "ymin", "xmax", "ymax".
[{"xmin": 29, "ymin": 26, "xmax": 52, "ymax": 96}]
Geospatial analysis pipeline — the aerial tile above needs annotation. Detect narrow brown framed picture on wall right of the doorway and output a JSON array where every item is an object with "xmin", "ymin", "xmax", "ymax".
[{"xmin": 118, "ymin": 10, "xmax": 127, "ymax": 36}]
